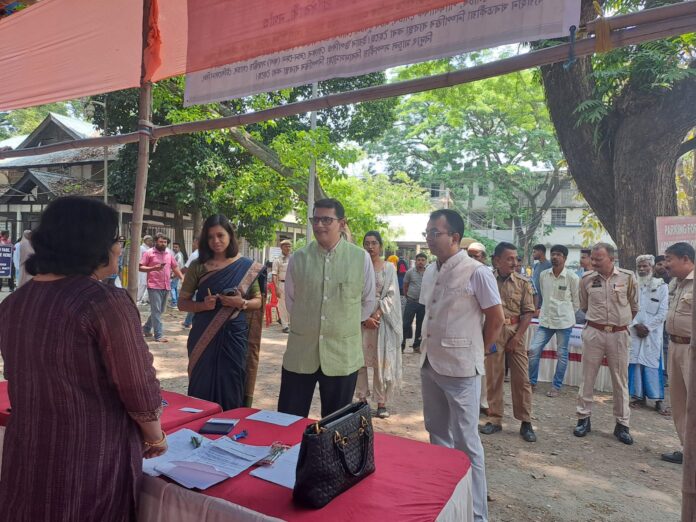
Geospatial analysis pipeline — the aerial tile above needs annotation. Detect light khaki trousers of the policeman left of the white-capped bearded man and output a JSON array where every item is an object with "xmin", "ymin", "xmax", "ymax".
[{"xmin": 577, "ymin": 326, "xmax": 631, "ymax": 427}]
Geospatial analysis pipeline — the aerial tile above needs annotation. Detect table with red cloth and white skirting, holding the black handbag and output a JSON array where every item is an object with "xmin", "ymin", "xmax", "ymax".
[{"xmin": 139, "ymin": 408, "xmax": 473, "ymax": 522}]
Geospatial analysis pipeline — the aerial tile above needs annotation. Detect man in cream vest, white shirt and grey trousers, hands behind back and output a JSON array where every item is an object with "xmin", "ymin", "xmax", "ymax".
[{"xmin": 420, "ymin": 209, "xmax": 505, "ymax": 521}]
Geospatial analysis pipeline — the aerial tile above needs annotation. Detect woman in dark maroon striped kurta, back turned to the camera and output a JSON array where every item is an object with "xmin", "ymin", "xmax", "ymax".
[{"xmin": 0, "ymin": 197, "xmax": 166, "ymax": 521}]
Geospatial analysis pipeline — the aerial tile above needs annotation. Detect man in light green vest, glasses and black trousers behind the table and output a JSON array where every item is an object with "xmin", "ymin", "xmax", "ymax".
[{"xmin": 278, "ymin": 199, "xmax": 377, "ymax": 417}]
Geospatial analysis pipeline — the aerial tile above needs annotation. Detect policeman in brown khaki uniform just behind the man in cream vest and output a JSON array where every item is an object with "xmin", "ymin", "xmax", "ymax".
[{"xmin": 480, "ymin": 242, "xmax": 536, "ymax": 442}]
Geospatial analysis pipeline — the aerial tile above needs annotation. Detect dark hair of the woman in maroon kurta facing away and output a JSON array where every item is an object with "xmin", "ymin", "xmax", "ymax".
[{"xmin": 25, "ymin": 196, "xmax": 118, "ymax": 276}]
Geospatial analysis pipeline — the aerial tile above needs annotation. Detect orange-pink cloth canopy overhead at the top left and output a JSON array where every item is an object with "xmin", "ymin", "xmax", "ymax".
[{"xmin": 0, "ymin": 0, "xmax": 468, "ymax": 110}]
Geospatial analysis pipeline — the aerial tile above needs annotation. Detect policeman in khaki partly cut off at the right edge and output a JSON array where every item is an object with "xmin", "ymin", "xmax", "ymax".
[{"xmin": 662, "ymin": 243, "xmax": 694, "ymax": 464}]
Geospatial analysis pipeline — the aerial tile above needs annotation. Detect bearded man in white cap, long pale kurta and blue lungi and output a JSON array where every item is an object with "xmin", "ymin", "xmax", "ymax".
[{"xmin": 628, "ymin": 255, "xmax": 669, "ymax": 414}]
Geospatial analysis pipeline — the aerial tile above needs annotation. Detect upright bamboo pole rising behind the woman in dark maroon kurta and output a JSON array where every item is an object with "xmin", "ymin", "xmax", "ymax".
[{"xmin": 128, "ymin": 0, "xmax": 152, "ymax": 302}]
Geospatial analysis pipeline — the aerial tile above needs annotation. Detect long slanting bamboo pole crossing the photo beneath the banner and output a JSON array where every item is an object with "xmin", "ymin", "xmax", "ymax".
[{"xmin": 0, "ymin": 2, "xmax": 696, "ymax": 159}]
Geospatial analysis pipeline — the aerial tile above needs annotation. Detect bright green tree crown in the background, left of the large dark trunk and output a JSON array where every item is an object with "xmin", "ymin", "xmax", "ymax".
[{"xmin": 372, "ymin": 62, "xmax": 562, "ymax": 250}]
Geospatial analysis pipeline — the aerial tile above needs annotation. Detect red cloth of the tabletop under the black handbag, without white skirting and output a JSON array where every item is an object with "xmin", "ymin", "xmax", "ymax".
[{"xmin": 157, "ymin": 408, "xmax": 470, "ymax": 522}]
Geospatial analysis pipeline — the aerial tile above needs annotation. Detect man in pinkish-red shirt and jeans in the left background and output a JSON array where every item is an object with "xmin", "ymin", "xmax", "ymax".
[{"xmin": 140, "ymin": 234, "xmax": 184, "ymax": 343}]
